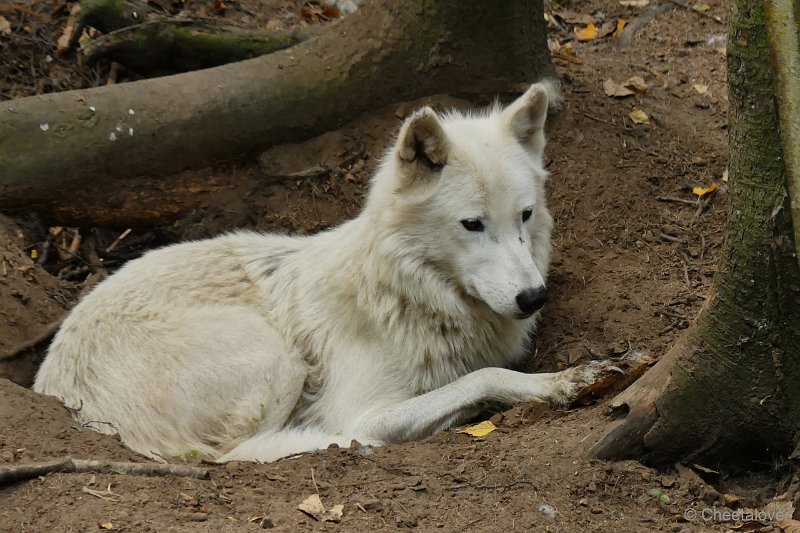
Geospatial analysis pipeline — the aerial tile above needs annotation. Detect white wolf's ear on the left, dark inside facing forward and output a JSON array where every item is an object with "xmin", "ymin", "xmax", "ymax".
[{"xmin": 397, "ymin": 107, "xmax": 448, "ymax": 184}]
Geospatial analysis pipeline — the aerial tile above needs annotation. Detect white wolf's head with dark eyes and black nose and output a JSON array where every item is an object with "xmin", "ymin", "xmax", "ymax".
[{"xmin": 367, "ymin": 84, "xmax": 554, "ymax": 319}]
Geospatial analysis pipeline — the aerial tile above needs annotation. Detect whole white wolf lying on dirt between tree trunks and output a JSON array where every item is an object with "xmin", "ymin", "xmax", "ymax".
[{"xmin": 34, "ymin": 84, "xmax": 614, "ymax": 461}]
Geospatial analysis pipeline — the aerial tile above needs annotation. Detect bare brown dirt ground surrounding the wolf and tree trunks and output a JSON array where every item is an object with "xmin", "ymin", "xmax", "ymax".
[{"xmin": 0, "ymin": 0, "xmax": 788, "ymax": 532}]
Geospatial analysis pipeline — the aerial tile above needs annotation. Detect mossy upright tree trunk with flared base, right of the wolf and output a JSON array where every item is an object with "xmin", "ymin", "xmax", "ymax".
[{"xmin": 590, "ymin": 0, "xmax": 800, "ymax": 468}]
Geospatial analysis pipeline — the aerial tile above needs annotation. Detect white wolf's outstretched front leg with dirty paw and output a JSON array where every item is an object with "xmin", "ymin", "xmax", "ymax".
[{"xmin": 359, "ymin": 362, "xmax": 619, "ymax": 442}]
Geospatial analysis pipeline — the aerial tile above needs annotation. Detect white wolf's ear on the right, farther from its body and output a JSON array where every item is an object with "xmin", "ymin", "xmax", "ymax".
[{"xmin": 503, "ymin": 83, "xmax": 549, "ymax": 157}]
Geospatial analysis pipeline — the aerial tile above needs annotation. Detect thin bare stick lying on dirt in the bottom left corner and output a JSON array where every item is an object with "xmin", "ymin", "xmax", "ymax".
[{"xmin": 0, "ymin": 458, "xmax": 209, "ymax": 485}]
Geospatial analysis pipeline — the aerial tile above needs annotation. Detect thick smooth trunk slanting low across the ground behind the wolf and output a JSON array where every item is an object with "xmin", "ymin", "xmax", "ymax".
[{"xmin": 0, "ymin": 0, "xmax": 553, "ymax": 221}]
